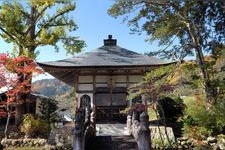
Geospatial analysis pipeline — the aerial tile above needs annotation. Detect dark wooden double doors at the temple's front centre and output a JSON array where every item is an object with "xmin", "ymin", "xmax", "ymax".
[{"xmin": 95, "ymin": 88, "xmax": 127, "ymax": 123}]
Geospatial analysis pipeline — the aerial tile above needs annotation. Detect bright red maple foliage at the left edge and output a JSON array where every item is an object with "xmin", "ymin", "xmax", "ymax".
[{"xmin": 0, "ymin": 53, "xmax": 42, "ymax": 118}]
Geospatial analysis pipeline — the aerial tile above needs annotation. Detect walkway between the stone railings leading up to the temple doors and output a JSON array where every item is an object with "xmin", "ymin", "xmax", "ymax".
[{"xmin": 85, "ymin": 123, "xmax": 137, "ymax": 150}]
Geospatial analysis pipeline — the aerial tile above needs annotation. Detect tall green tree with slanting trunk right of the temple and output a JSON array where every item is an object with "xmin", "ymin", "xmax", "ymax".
[{"xmin": 108, "ymin": 0, "xmax": 225, "ymax": 102}]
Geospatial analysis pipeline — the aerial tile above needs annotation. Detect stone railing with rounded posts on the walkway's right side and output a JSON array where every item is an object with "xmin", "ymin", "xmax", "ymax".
[{"xmin": 127, "ymin": 111, "xmax": 151, "ymax": 150}]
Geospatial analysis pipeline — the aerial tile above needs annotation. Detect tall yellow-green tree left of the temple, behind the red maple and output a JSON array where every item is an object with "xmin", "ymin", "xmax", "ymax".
[{"xmin": 0, "ymin": 0, "xmax": 85, "ymax": 124}]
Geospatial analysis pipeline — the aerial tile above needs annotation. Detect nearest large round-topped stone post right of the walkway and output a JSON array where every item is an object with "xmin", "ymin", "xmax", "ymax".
[{"xmin": 137, "ymin": 112, "xmax": 151, "ymax": 150}]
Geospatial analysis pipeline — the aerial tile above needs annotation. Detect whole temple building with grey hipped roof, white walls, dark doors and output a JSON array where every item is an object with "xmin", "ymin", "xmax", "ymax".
[{"xmin": 38, "ymin": 35, "xmax": 171, "ymax": 122}]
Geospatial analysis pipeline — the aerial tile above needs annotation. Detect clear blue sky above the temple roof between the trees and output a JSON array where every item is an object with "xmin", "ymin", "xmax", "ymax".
[{"xmin": 0, "ymin": 0, "xmax": 159, "ymax": 81}]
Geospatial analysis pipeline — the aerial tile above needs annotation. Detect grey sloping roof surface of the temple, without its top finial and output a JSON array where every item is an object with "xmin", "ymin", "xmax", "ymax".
[{"xmin": 39, "ymin": 46, "xmax": 170, "ymax": 68}]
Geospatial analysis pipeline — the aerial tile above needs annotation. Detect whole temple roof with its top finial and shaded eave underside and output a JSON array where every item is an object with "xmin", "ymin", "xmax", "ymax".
[{"xmin": 38, "ymin": 35, "xmax": 172, "ymax": 86}]
